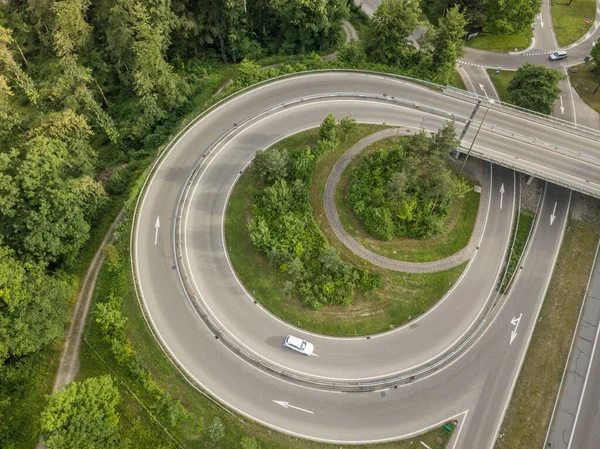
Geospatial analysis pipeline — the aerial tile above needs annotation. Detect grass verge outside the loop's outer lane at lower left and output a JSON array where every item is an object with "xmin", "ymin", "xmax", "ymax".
[{"xmin": 77, "ymin": 214, "xmax": 449, "ymax": 449}]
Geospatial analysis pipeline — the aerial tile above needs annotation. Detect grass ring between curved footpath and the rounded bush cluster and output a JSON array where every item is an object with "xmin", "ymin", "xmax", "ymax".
[{"xmin": 335, "ymin": 137, "xmax": 480, "ymax": 262}]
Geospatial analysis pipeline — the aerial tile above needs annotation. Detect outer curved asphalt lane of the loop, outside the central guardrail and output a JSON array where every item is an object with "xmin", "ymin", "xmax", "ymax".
[{"xmin": 134, "ymin": 75, "xmax": 576, "ymax": 442}]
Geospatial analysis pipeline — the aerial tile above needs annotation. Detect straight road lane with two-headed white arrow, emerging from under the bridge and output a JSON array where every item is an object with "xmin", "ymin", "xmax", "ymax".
[{"xmin": 464, "ymin": 184, "xmax": 571, "ymax": 448}]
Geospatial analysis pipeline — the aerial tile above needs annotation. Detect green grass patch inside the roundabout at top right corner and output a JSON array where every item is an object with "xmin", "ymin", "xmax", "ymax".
[{"xmin": 550, "ymin": 0, "xmax": 596, "ymax": 47}]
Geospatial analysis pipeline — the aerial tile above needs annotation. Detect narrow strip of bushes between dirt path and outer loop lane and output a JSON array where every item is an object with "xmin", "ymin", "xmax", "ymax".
[{"xmin": 94, "ymin": 244, "xmax": 187, "ymax": 426}]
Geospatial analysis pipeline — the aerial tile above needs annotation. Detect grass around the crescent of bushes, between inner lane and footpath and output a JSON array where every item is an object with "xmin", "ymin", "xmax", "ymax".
[{"xmin": 225, "ymin": 125, "xmax": 466, "ymax": 336}]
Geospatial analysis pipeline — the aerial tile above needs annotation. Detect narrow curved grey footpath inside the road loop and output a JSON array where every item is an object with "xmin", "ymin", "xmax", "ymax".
[{"xmin": 324, "ymin": 128, "xmax": 491, "ymax": 273}]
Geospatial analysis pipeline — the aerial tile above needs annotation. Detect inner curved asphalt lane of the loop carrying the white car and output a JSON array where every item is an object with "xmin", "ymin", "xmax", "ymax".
[{"xmin": 183, "ymin": 100, "xmax": 514, "ymax": 380}]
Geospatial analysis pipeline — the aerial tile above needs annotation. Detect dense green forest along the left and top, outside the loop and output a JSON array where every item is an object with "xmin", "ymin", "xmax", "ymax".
[{"xmin": 0, "ymin": 0, "xmax": 502, "ymax": 447}]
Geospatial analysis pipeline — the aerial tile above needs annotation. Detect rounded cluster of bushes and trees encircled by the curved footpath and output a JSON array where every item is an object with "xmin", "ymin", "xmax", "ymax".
[{"xmin": 348, "ymin": 123, "xmax": 470, "ymax": 241}]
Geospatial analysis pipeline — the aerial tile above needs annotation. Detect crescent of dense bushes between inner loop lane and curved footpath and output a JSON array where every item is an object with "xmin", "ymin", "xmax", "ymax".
[{"xmin": 248, "ymin": 115, "xmax": 381, "ymax": 309}]
